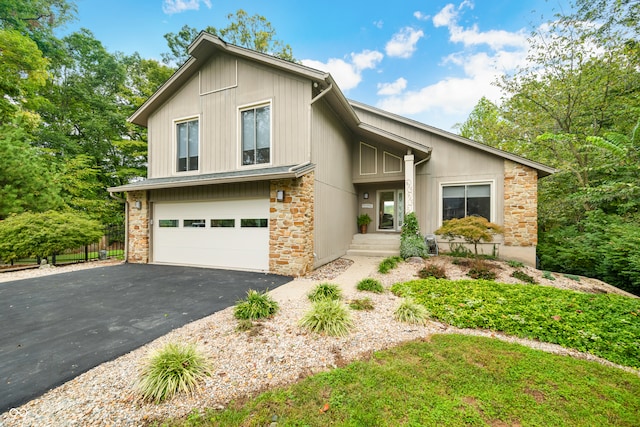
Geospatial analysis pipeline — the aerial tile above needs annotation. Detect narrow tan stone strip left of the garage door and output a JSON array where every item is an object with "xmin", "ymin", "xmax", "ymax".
[{"xmin": 127, "ymin": 191, "xmax": 149, "ymax": 264}]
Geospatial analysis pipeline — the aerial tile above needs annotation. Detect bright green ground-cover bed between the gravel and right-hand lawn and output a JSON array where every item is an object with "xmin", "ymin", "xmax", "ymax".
[{"xmin": 391, "ymin": 279, "xmax": 640, "ymax": 368}]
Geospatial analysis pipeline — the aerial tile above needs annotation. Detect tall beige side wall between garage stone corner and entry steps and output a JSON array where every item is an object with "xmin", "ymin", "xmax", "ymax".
[{"xmin": 311, "ymin": 100, "xmax": 357, "ymax": 267}]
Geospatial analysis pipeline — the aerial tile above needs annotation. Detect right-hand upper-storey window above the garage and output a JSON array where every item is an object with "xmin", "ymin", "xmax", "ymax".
[{"xmin": 240, "ymin": 105, "xmax": 271, "ymax": 165}]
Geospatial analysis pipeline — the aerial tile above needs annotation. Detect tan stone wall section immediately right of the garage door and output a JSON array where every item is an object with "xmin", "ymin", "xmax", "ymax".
[{"xmin": 269, "ymin": 172, "xmax": 314, "ymax": 276}]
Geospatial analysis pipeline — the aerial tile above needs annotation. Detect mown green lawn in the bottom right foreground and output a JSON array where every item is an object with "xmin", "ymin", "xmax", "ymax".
[{"xmin": 164, "ymin": 335, "xmax": 640, "ymax": 427}]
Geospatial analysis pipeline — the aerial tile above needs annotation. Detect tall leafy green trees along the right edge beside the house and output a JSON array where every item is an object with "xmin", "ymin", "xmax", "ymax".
[{"xmin": 484, "ymin": 0, "xmax": 640, "ymax": 292}]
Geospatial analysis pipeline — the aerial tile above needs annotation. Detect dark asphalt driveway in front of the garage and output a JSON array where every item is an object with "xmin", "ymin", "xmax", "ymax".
[{"xmin": 0, "ymin": 264, "xmax": 291, "ymax": 413}]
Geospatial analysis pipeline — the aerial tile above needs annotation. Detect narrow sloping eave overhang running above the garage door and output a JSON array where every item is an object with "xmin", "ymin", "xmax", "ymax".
[{"xmin": 107, "ymin": 162, "xmax": 315, "ymax": 193}]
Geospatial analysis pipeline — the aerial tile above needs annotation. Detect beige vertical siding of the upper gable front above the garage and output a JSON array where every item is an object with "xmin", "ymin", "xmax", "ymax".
[{"xmin": 148, "ymin": 54, "xmax": 311, "ymax": 178}]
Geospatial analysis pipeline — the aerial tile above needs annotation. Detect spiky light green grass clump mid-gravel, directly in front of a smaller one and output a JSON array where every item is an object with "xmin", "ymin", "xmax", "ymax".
[{"xmin": 300, "ymin": 298, "xmax": 353, "ymax": 337}]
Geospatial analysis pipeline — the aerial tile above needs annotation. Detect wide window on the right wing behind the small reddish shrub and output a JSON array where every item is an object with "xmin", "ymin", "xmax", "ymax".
[{"xmin": 442, "ymin": 184, "xmax": 491, "ymax": 221}]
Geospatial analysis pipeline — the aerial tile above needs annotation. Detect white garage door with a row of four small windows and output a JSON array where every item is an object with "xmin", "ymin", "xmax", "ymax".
[{"xmin": 152, "ymin": 199, "xmax": 269, "ymax": 271}]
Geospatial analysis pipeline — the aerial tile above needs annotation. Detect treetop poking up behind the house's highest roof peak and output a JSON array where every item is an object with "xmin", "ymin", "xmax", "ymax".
[{"xmin": 162, "ymin": 9, "xmax": 294, "ymax": 64}]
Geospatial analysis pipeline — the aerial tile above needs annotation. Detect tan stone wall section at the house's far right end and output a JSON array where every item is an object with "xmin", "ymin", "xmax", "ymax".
[{"xmin": 504, "ymin": 160, "xmax": 538, "ymax": 246}]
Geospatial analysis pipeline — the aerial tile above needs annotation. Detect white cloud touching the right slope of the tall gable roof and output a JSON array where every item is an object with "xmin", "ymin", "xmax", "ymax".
[{"xmin": 301, "ymin": 50, "xmax": 384, "ymax": 91}]
